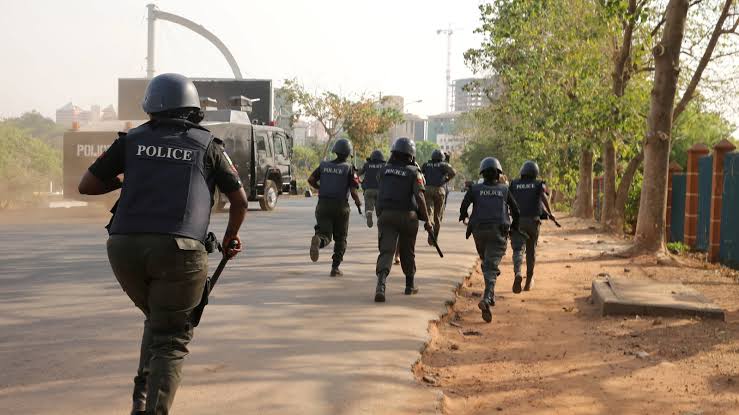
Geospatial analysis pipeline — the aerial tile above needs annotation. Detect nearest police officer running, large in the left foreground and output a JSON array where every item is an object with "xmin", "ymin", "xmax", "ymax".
[{"xmin": 79, "ymin": 74, "xmax": 247, "ymax": 415}]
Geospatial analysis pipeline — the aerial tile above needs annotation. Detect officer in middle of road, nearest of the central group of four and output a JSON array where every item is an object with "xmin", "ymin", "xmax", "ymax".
[{"xmin": 375, "ymin": 137, "xmax": 433, "ymax": 303}]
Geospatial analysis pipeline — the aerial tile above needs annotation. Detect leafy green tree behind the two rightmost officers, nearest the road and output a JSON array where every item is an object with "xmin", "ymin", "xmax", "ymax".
[{"xmin": 465, "ymin": 0, "xmax": 612, "ymax": 217}]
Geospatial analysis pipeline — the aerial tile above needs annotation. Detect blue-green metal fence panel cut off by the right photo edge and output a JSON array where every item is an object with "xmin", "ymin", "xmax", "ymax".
[{"xmin": 724, "ymin": 153, "xmax": 739, "ymax": 268}]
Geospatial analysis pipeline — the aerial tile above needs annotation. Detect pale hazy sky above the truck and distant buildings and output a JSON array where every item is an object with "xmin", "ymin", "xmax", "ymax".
[{"xmin": 0, "ymin": 0, "xmax": 480, "ymax": 118}]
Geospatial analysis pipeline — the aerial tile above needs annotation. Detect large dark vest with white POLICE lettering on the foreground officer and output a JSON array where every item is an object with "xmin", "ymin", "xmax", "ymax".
[{"xmin": 110, "ymin": 123, "xmax": 214, "ymax": 241}]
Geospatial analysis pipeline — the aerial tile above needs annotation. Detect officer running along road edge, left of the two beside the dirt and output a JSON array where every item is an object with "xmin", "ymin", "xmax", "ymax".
[{"xmin": 459, "ymin": 157, "xmax": 519, "ymax": 323}]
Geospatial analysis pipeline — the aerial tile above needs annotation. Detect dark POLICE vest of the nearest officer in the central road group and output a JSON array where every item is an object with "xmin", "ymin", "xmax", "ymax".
[{"xmin": 377, "ymin": 163, "xmax": 418, "ymax": 212}]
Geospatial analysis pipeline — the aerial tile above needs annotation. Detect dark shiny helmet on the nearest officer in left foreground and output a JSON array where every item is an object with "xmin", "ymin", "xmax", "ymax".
[{"xmin": 141, "ymin": 73, "xmax": 200, "ymax": 114}]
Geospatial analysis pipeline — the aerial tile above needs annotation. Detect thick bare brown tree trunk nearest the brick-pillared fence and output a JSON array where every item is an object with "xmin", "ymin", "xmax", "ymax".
[{"xmin": 632, "ymin": 0, "xmax": 688, "ymax": 253}]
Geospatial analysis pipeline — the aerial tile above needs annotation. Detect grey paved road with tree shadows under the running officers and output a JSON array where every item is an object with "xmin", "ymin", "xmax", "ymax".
[{"xmin": 0, "ymin": 193, "xmax": 475, "ymax": 415}]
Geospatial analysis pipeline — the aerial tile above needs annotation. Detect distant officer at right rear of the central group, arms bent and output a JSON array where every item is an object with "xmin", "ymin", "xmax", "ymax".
[{"xmin": 421, "ymin": 149, "xmax": 457, "ymax": 245}]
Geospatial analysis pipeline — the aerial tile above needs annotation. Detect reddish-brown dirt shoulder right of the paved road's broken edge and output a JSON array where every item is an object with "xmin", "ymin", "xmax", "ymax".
[{"xmin": 414, "ymin": 219, "xmax": 739, "ymax": 415}]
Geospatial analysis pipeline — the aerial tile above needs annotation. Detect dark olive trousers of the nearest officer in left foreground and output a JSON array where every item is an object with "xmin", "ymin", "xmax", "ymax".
[{"xmin": 107, "ymin": 234, "xmax": 208, "ymax": 415}]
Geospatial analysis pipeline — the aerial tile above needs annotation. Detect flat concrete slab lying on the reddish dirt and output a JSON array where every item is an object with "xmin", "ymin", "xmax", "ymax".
[{"xmin": 592, "ymin": 277, "xmax": 725, "ymax": 320}]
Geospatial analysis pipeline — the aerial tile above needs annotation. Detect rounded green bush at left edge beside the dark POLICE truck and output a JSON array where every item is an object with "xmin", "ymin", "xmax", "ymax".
[{"xmin": 0, "ymin": 121, "xmax": 62, "ymax": 206}]
